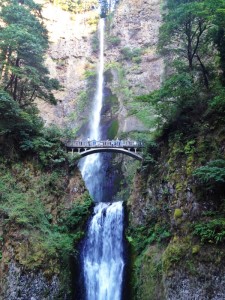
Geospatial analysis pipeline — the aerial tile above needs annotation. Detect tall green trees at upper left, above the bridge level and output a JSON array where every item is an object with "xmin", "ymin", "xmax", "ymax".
[{"xmin": 0, "ymin": 0, "xmax": 59, "ymax": 155}]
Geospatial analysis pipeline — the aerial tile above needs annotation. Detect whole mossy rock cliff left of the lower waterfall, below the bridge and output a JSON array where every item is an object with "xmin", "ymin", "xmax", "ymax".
[{"xmin": 0, "ymin": 160, "xmax": 91, "ymax": 300}]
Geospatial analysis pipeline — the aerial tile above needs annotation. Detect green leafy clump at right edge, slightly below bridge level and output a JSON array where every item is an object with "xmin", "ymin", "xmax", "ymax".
[{"xmin": 193, "ymin": 159, "xmax": 225, "ymax": 187}]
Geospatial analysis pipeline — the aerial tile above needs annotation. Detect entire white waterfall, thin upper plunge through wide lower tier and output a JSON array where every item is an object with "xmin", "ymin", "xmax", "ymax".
[{"xmin": 80, "ymin": 4, "xmax": 124, "ymax": 300}]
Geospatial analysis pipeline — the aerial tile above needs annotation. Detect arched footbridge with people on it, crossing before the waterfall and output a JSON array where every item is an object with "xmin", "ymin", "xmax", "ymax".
[{"xmin": 65, "ymin": 140, "xmax": 144, "ymax": 160}]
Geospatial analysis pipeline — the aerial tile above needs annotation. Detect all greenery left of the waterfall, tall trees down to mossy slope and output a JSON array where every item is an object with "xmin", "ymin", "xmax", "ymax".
[{"xmin": 0, "ymin": 0, "xmax": 89, "ymax": 290}]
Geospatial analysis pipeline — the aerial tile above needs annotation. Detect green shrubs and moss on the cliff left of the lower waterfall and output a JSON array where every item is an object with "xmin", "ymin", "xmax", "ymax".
[{"xmin": 0, "ymin": 163, "xmax": 92, "ymax": 272}]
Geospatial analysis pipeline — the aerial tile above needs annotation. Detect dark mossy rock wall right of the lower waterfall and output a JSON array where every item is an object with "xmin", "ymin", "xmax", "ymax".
[{"xmin": 127, "ymin": 127, "xmax": 225, "ymax": 300}]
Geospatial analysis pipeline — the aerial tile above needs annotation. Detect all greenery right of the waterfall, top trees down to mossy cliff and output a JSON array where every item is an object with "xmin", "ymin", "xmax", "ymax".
[{"xmin": 128, "ymin": 0, "xmax": 225, "ymax": 299}]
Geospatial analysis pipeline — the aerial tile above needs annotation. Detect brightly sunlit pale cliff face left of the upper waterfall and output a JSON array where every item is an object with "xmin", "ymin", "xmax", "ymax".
[{"xmin": 38, "ymin": 1, "xmax": 98, "ymax": 128}]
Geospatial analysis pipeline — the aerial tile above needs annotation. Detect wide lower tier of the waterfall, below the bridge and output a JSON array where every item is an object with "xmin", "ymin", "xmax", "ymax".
[{"xmin": 83, "ymin": 202, "xmax": 124, "ymax": 300}]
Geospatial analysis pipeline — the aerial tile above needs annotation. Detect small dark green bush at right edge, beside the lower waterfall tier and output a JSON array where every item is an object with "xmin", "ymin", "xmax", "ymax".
[{"xmin": 193, "ymin": 218, "xmax": 225, "ymax": 244}]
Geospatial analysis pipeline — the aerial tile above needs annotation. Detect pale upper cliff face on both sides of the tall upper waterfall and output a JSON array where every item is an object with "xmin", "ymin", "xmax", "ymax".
[{"xmin": 38, "ymin": 0, "xmax": 163, "ymax": 133}]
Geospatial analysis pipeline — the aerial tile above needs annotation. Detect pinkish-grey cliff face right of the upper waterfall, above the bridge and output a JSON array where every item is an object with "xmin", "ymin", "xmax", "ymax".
[{"xmin": 105, "ymin": 0, "xmax": 164, "ymax": 132}]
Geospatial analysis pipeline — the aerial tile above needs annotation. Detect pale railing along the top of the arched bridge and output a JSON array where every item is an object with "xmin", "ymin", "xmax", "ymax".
[{"xmin": 65, "ymin": 140, "xmax": 144, "ymax": 148}]
